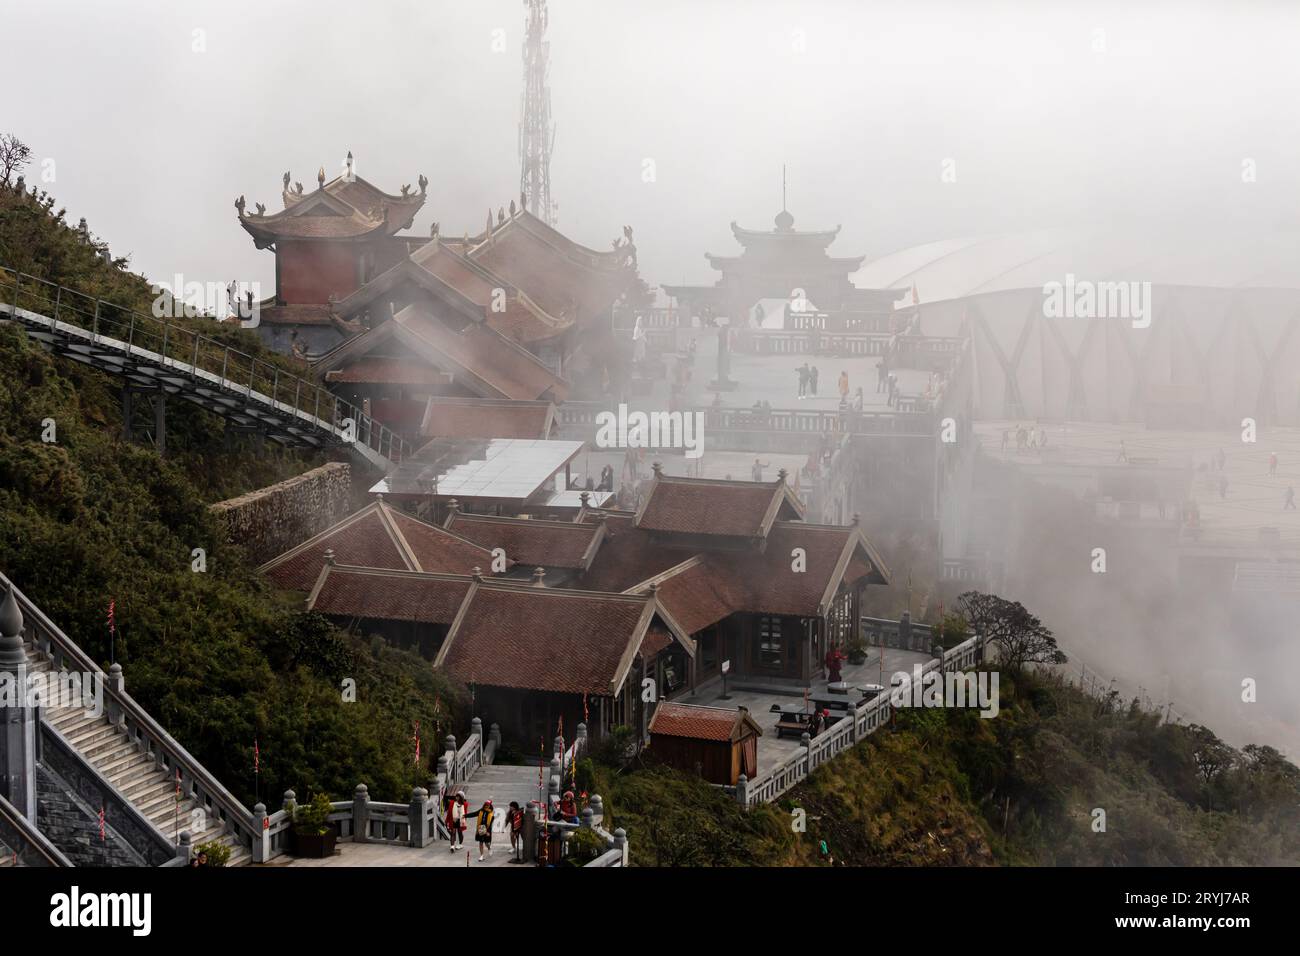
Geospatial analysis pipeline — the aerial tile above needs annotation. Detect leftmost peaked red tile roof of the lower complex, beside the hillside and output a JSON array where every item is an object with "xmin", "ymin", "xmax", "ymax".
[{"xmin": 261, "ymin": 502, "xmax": 491, "ymax": 591}]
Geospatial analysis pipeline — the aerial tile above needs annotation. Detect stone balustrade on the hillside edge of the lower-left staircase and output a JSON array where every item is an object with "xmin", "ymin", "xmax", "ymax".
[{"xmin": 0, "ymin": 572, "xmax": 261, "ymax": 848}]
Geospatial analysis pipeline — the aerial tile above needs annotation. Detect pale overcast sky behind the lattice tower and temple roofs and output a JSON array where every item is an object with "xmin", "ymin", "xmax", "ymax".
[{"xmin": 0, "ymin": 0, "xmax": 1300, "ymax": 299}]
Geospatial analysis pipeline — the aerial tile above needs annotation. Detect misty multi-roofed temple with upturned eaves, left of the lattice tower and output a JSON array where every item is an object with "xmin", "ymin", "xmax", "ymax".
[{"xmin": 235, "ymin": 153, "xmax": 640, "ymax": 437}]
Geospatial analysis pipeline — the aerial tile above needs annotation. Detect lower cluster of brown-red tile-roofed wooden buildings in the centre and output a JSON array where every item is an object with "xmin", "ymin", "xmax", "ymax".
[{"xmin": 263, "ymin": 467, "xmax": 889, "ymax": 740}]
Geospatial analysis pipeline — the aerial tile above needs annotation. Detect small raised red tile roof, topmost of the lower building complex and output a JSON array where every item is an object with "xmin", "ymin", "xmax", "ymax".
[{"xmin": 636, "ymin": 475, "xmax": 802, "ymax": 538}]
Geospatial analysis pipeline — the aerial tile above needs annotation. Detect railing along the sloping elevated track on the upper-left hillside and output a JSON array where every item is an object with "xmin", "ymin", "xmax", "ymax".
[{"xmin": 0, "ymin": 265, "xmax": 406, "ymax": 462}]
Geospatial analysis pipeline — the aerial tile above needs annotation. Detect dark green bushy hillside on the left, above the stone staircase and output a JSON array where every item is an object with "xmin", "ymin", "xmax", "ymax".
[{"xmin": 0, "ymin": 170, "xmax": 460, "ymax": 806}]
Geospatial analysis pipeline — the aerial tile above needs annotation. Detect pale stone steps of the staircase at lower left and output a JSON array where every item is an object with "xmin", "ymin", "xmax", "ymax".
[{"xmin": 25, "ymin": 643, "xmax": 251, "ymax": 866}]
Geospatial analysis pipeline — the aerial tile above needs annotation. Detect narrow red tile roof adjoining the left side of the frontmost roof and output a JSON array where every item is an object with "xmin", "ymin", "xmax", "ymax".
[{"xmin": 307, "ymin": 564, "xmax": 473, "ymax": 624}]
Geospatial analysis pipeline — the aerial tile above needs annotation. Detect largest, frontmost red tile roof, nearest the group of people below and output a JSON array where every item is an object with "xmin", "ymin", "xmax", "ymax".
[{"xmin": 434, "ymin": 581, "xmax": 654, "ymax": 696}]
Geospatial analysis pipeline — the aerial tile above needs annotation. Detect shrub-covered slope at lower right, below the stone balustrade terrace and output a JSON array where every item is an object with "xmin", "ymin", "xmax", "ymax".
[{"xmin": 592, "ymin": 672, "xmax": 1300, "ymax": 866}]
